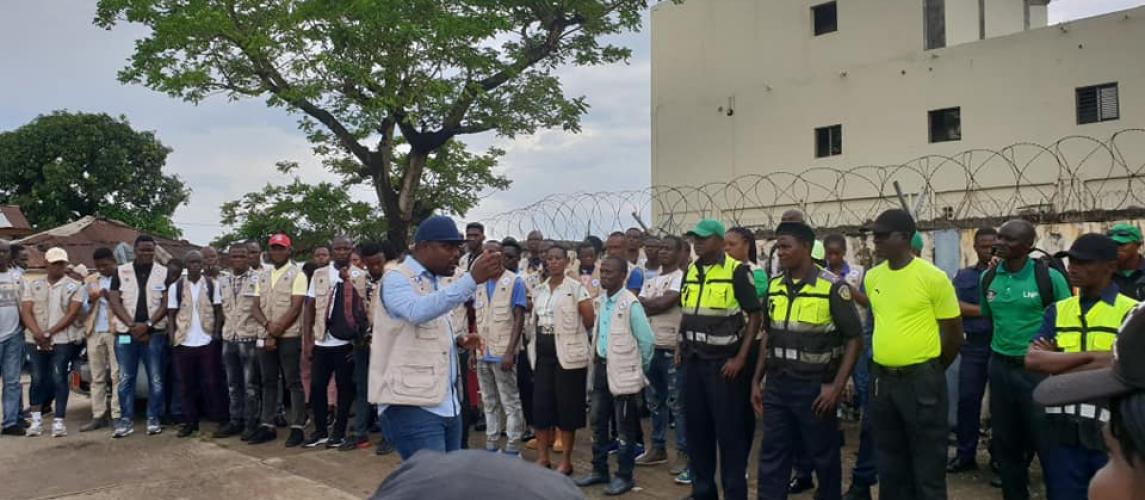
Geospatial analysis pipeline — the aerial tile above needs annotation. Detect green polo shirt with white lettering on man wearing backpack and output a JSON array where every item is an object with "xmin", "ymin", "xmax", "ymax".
[{"xmin": 980, "ymin": 259, "xmax": 1069, "ymax": 356}]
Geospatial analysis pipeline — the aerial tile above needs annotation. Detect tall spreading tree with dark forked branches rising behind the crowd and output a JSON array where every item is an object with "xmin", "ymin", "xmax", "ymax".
[{"xmin": 96, "ymin": 0, "xmax": 647, "ymax": 245}]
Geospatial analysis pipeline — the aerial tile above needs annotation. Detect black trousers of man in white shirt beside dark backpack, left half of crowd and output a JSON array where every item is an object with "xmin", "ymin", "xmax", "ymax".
[{"xmin": 310, "ymin": 344, "xmax": 354, "ymax": 437}]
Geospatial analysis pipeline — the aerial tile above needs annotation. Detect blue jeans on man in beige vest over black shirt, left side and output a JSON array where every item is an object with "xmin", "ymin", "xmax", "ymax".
[{"xmin": 116, "ymin": 332, "xmax": 167, "ymax": 421}]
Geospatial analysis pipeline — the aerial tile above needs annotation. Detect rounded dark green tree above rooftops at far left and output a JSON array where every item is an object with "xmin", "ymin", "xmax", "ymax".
[{"xmin": 0, "ymin": 111, "xmax": 190, "ymax": 238}]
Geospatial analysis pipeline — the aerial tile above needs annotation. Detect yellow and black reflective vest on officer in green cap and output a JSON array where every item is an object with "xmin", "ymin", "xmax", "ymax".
[{"xmin": 680, "ymin": 255, "xmax": 744, "ymax": 358}]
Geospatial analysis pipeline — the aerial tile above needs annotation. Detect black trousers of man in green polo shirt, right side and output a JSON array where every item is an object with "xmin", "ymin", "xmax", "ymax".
[{"xmin": 989, "ymin": 352, "xmax": 1050, "ymax": 500}]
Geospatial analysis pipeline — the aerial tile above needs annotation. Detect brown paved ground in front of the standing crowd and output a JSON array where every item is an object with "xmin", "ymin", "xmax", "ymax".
[{"xmin": 0, "ymin": 381, "xmax": 1041, "ymax": 499}]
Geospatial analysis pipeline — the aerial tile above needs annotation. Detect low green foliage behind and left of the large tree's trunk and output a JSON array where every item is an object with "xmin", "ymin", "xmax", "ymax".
[{"xmin": 212, "ymin": 177, "xmax": 386, "ymax": 253}]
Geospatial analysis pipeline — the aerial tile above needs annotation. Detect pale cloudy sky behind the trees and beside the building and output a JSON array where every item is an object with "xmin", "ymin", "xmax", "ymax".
[{"xmin": 0, "ymin": 0, "xmax": 1145, "ymax": 243}]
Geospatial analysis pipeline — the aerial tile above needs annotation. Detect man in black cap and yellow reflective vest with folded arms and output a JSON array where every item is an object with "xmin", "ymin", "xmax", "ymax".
[{"xmin": 1026, "ymin": 233, "xmax": 1137, "ymax": 500}]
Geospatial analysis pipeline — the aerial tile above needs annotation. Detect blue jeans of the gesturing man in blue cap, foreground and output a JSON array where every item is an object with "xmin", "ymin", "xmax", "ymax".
[{"xmin": 381, "ymin": 406, "xmax": 461, "ymax": 460}]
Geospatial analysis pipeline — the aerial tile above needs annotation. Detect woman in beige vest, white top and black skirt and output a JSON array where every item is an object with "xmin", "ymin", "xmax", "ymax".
[{"xmin": 529, "ymin": 246, "xmax": 595, "ymax": 475}]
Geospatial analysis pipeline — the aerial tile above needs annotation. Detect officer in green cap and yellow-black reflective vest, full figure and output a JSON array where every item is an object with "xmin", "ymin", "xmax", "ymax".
[{"xmin": 680, "ymin": 219, "xmax": 763, "ymax": 500}]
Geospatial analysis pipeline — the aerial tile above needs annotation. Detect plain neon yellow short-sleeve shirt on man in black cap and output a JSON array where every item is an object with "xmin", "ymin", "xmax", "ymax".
[{"xmin": 863, "ymin": 259, "xmax": 961, "ymax": 367}]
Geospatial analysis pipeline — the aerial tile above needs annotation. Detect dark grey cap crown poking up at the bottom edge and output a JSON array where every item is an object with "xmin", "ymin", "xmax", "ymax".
[{"xmin": 370, "ymin": 450, "xmax": 584, "ymax": 500}]
